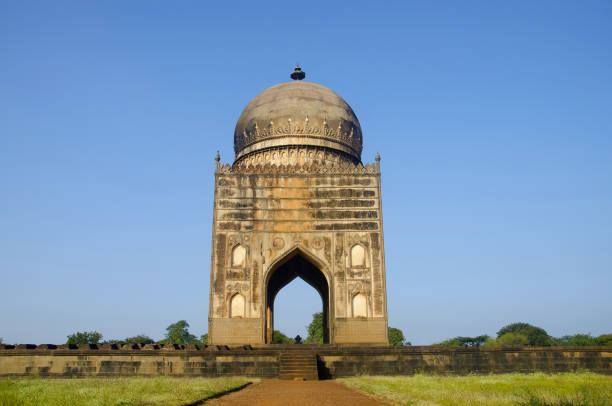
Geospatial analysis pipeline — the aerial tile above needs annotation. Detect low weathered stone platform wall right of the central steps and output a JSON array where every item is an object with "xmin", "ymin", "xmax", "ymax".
[{"xmin": 317, "ymin": 347, "xmax": 612, "ymax": 378}]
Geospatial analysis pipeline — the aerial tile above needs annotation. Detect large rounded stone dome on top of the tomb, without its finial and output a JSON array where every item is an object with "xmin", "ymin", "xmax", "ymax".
[{"xmin": 234, "ymin": 77, "xmax": 362, "ymax": 164}]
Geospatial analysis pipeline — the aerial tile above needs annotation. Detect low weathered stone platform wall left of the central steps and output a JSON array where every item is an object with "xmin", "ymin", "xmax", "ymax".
[{"xmin": 0, "ymin": 344, "xmax": 279, "ymax": 378}]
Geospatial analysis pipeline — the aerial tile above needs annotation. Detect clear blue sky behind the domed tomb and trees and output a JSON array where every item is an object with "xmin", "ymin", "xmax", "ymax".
[{"xmin": 0, "ymin": 1, "xmax": 612, "ymax": 344}]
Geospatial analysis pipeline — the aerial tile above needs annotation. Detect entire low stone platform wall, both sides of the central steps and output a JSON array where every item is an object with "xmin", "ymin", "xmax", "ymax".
[{"xmin": 0, "ymin": 344, "xmax": 612, "ymax": 378}]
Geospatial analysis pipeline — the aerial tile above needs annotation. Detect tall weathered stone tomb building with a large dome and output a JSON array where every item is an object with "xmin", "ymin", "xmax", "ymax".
[{"xmin": 208, "ymin": 67, "xmax": 388, "ymax": 345}]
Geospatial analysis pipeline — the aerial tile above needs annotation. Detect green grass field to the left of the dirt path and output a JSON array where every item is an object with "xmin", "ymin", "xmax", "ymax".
[{"xmin": 0, "ymin": 377, "xmax": 254, "ymax": 406}]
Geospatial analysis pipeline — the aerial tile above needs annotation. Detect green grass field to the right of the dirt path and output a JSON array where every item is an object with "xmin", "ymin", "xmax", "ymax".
[{"xmin": 339, "ymin": 373, "xmax": 612, "ymax": 406}]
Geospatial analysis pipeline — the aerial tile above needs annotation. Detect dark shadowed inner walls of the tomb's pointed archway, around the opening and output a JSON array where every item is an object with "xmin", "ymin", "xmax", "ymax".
[{"xmin": 265, "ymin": 248, "xmax": 329, "ymax": 344}]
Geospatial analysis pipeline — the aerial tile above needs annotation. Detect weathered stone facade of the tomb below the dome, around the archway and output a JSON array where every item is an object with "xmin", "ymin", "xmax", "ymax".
[{"xmin": 208, "ymin": 162, "xmax": 388, "ymax": 345}]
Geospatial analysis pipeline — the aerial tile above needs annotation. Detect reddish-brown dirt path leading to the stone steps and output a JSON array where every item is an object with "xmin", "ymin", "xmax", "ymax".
[{"xmin": 206, "ymin": 379, "xmax": 392, "ymax": 406}]
